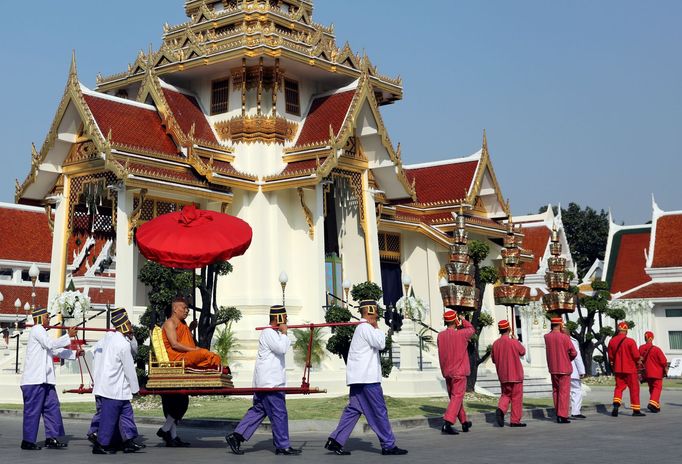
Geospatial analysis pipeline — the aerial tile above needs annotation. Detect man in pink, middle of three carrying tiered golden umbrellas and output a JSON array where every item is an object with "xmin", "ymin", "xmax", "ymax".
[{"xmin": 492, "ymin": 320, "xmax": 526, "ymax": 427}]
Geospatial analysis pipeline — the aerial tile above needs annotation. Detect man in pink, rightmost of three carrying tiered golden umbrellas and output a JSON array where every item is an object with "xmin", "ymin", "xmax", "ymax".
[{"xmin": 545, "ymin": 317, "xmax": 578, "ymax": 424}]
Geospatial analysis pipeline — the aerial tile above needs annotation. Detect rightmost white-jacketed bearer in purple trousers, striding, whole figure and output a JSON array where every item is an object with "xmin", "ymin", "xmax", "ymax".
[{"xmin": 324, "ymin": 300, "xmax": 407, "ymax": 456}]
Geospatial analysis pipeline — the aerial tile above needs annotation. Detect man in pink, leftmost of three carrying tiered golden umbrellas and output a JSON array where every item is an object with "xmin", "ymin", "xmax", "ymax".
[{"xmin": 438, "ymin": 310, "xmax": 476, "ymax": 435}]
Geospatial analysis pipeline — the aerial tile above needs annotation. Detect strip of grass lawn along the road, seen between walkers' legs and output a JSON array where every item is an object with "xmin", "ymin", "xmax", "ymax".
[{"xmin": 0, "ymin": 393, "xmax": 552, "ymax": 420}]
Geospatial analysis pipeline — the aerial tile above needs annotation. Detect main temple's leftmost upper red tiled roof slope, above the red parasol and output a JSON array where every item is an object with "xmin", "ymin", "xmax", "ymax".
[{"xmin": 83, "ymin": 94, "xmax": 178, "ymax": 155}]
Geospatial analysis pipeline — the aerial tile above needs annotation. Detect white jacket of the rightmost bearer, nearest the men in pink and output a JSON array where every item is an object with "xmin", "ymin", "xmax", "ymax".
[{"xmin": 346, "ymin": 319, "xmax": 386, "ymax": 385}]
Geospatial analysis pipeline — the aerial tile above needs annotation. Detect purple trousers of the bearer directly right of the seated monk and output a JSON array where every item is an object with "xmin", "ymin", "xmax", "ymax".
[{"xmin": 234, "ymin": 392, "xmax": 291, "ymax": 449}]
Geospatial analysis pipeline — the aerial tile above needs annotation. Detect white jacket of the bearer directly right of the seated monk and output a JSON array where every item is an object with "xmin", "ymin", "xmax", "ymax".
[{"xmin": 253, "ymin": 329, "xmax": 291, "ymax": 388}]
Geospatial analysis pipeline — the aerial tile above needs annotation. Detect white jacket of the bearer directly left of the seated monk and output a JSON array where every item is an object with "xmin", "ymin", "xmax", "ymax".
[{"xmin": 92, "ymin": 332, "xmax": 140, "ymax": 400}]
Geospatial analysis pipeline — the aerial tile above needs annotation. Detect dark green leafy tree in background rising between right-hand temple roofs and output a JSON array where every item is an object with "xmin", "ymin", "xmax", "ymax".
[{"xmin": 539, "ymin": 203, "xmax": 609, "ymax": 276}]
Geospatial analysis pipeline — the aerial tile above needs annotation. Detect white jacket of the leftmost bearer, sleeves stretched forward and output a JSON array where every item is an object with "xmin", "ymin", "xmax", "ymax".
[{"xmin": 21, "ymin": 325, "xmax": 76, "ymax": 385}]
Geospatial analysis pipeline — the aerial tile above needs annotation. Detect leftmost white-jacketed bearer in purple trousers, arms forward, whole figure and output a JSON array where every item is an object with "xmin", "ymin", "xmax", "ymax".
[{"xmin": 21, "ymin": 308, "xmax": 77, "ymax": 450}]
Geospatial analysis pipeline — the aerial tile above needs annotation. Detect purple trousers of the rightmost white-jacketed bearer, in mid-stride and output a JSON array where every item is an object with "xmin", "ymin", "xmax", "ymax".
[{"xmin": 329, "ymin": 383, "xmax": 395, "ymax": 449}]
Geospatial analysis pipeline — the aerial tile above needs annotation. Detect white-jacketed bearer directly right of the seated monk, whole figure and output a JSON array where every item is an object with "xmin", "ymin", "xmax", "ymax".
[{"xmin": 225, "ymin": 305, "xmax": 301, "ymax": 455}]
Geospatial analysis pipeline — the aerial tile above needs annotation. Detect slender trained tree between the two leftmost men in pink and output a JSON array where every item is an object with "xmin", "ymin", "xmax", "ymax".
[{"xmin": 467, "ymin": 240, "xmax": 498, "ymax": 392}]
